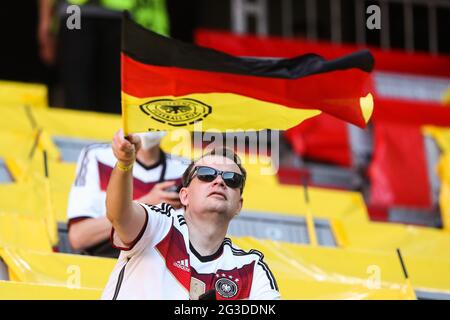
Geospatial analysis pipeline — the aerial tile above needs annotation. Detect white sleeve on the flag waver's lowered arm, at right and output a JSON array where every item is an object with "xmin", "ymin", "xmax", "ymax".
[{"xmin": 249, "ymin": 260, "xmax": 281, "ymax": 300}]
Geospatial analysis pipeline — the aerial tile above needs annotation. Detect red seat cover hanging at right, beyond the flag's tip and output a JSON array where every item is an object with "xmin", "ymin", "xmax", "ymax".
[{"xmin": 369, "ymin": 122, "xmax": 431, "ymax": 209}]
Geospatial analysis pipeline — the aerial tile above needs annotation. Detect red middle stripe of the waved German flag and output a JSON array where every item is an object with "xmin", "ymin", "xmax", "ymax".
[{"xmin": 122, "ymin": 53, "xmax": 372, "ymax": 127}]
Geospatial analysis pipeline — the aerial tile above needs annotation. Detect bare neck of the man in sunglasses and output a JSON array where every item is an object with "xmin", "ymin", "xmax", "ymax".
[{"xmin": 184, "ymin": 210, "xmax": 229, "ymax": 256}]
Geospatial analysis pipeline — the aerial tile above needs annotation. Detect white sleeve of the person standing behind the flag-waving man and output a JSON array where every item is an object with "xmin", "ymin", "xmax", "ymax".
[{"xmin": 67, "ymin": 146, "xmax": 106, "ymax": 220}]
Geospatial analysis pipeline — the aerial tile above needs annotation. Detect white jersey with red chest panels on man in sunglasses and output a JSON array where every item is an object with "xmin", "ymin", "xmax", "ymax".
[{"xmin": 102, "ymin": 203, "xmax": 280, "ymax": 300}]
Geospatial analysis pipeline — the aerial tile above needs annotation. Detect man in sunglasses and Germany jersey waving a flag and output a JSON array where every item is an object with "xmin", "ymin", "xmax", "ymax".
[{"xmin": 102, "ymin": 131, "xmax": 280, "ymax": 300}]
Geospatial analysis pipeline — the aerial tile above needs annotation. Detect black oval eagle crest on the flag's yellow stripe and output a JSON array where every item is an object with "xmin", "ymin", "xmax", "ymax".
[{"xmin": 139, "ymin": 98, "xmax": 212, "ymax": 127}]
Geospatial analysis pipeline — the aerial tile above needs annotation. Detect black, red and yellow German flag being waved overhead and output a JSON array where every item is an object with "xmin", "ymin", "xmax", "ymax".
[{"xmin": 121, "ymin": 15, "xmax": 374, "ymax": 133}]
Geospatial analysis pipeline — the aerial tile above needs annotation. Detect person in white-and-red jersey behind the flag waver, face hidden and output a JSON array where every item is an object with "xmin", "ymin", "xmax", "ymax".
[{"xmin": 67, "ymin": 132, "xmax": 189, "ymax": 258}]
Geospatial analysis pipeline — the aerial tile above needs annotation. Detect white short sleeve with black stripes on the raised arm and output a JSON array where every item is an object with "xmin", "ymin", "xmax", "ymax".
[{"xmin": 111, "ymin": 202, "xmax": 175, "ymax": 257}]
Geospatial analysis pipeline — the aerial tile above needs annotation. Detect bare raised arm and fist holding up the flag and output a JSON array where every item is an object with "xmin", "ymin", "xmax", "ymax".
[{"xmin": 106, "ymin": 130, "xmax": 145, "ymax": 244}]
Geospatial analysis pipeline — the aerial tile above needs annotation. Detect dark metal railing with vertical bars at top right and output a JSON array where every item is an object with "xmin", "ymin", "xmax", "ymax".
[{"xmin": 231, "ymin": 0, "xmax": 450, "ymax": 54}]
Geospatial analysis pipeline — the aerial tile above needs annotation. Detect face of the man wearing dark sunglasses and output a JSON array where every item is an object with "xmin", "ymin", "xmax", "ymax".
[{"xmin": 180, "ymin": 155, "xmax": 243, "ymax": 220}]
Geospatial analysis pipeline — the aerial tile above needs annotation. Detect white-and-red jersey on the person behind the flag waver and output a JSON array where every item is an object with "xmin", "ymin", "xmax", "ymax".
[{"xmin": 67, "ymin": 143, "xmax": 190, "ymax": 224}]
